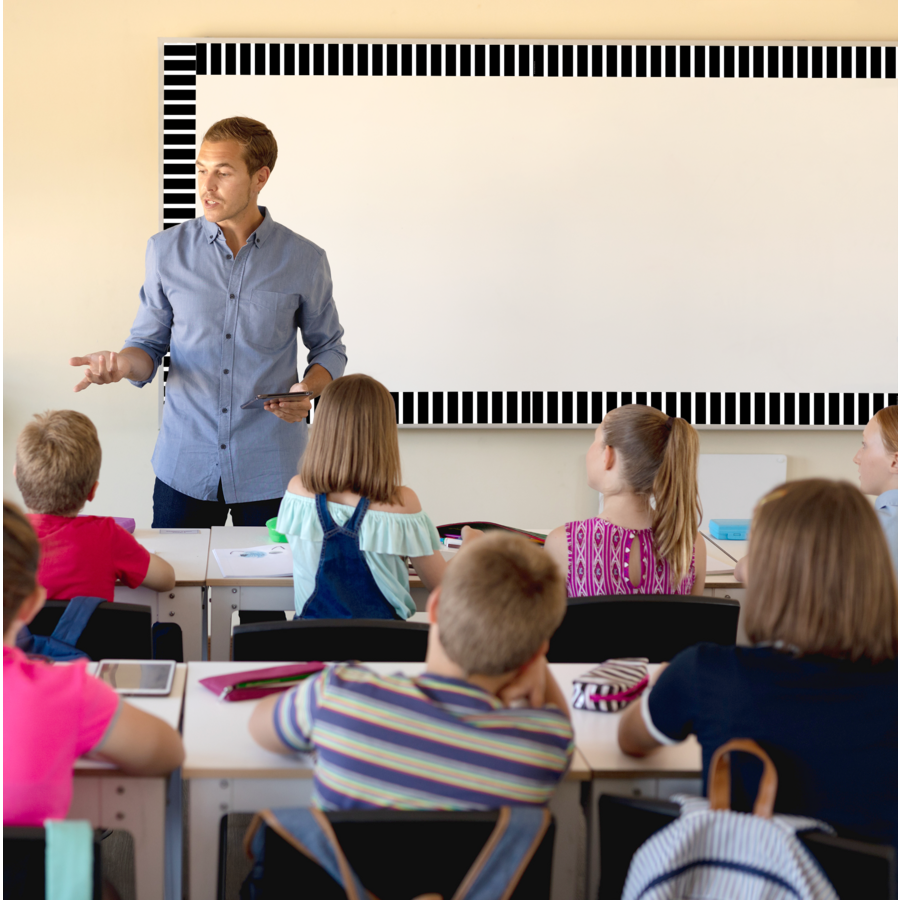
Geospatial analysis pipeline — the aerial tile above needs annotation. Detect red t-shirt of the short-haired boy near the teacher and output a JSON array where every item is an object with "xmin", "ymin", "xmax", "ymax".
[{"xmin": 28, "ymin": 513, "xmax": 150, "ymax": 600}]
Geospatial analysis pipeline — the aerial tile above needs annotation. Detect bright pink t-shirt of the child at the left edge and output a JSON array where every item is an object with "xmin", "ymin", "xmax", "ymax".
[{"xmin": 3, "ymin": 647, "xmax": 119, "ymax": 825}]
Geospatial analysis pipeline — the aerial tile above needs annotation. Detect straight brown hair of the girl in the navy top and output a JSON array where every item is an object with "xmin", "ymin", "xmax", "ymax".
[{"xmin": 744, "ymin": 478, "xmax": 897, "ymax": 661}]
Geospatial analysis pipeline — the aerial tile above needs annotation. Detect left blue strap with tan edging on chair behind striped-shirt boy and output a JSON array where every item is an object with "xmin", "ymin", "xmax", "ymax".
[{"xmin": 244, "ymin": 809, "xmax": 375, "ymax": 900}]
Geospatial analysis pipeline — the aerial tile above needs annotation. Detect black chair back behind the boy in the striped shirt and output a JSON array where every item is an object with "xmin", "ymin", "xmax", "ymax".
[{"xmin": 219, "ymin": 809, "xmax": 556, "ymax": 900}]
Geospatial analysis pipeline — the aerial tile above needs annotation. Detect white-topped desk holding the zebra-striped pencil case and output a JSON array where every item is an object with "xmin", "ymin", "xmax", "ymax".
[{"xmin": 550, "ymin": 663, "xmax": 703, "ymax": 898}]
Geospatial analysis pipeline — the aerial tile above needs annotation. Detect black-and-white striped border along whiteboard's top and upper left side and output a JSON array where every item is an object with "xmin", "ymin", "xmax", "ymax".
[{"xmin": 162, "ymin": 41, "xmax": 897, "ymax": 228}]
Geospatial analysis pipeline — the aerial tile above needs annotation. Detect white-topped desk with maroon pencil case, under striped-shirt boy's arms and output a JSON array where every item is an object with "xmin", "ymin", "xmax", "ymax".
[{"xmin": 182, "ymin": 662, "xmax": 590, "ymax": 900}]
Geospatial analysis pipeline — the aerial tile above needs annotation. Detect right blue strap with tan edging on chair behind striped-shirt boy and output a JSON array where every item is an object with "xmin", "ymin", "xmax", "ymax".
[{"xmin": 453, "ymin": 806, "xmax": 550, "ymax": 900}]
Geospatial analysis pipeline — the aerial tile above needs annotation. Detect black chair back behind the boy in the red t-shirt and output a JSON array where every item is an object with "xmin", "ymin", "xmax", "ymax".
[{"xmin": 28, "ymin": 600, "xmax": 153, "ymax": 661}]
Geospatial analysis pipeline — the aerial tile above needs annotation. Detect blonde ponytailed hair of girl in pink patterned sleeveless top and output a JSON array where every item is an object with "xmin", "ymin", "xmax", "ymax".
[{"xmin": 603, "ymin": 404, "xmax": 703, "ymax": 583}]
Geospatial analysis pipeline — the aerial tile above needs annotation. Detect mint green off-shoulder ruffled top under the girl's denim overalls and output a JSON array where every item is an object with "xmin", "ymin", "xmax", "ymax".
[{"xmin": 275, "ymin": 491, "xmax": 441, "ymax": 619}]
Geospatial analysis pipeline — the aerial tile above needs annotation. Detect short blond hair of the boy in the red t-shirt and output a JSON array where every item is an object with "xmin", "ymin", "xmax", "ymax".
[{"xmin": 16, "ymin": 409, "xmax": 101, "ymax": 516}]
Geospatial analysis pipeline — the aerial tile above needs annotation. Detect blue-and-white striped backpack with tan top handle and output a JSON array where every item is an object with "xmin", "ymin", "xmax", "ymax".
[{"xmin": 622, "ymin": 738, "xmax": 838, "ymax": 900}]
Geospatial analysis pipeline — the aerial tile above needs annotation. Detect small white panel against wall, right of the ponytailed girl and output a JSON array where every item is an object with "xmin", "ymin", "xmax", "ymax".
[{"xmin": 697, "ymin": 453, "xmax": 787, "ymax": 534}]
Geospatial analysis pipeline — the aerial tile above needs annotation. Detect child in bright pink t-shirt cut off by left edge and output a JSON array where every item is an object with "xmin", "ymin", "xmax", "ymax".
[{"xmin": 3, "ymin": 501, "xmax": 184, "ymax": 826}]
